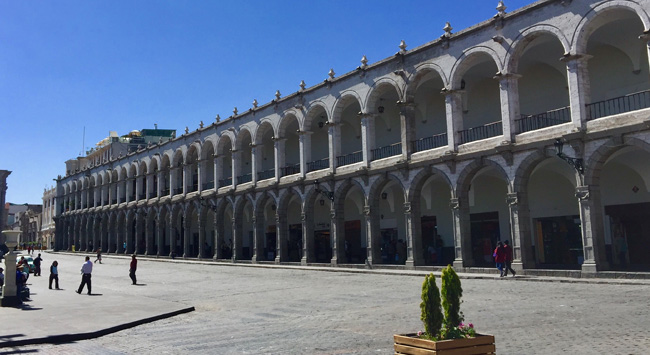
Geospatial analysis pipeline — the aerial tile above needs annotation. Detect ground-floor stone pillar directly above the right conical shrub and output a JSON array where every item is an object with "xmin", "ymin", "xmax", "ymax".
[{"xmin": 450, "ymin": 197, "xmax": 473, "ymax": 269}]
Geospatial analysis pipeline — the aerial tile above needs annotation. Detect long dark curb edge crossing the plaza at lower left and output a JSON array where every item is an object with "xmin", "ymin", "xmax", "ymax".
[{"xmin": 0, "ymin": 307, "xmax": 195, "ymax": 348}]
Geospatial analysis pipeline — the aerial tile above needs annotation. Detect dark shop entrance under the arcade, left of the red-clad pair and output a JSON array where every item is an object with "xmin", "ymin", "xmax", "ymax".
[{"xmin": 469, "ymin": 212, "xmax": 501, "ymax": 267}]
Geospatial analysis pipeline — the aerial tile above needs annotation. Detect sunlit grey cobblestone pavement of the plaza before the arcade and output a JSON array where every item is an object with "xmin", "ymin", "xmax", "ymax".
[{"xmin": 7, "ymin": 255, "xmax": 650, "ymax": 355}]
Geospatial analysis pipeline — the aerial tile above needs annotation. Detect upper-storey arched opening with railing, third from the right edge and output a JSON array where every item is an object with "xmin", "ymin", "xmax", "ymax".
[{"xmin": 458, "ymin": 53, "xmax": 503, "ymax": 144}]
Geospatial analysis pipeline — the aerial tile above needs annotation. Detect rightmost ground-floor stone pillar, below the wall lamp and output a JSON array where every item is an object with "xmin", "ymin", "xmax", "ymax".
[{"xmin": 576, "ymin": 186, "xmax": 609, "ymax": 273}]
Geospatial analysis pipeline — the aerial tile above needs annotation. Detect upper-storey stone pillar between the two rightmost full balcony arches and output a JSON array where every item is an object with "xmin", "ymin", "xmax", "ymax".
[{"xmin": 563, "ymin": 54, "xmax": 591, "ymax": 130}]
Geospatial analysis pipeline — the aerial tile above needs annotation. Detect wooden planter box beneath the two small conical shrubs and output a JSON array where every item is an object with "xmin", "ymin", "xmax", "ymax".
[{"xmin": 394, "ymin": 334, "xmax": 496, "ymax": 355}]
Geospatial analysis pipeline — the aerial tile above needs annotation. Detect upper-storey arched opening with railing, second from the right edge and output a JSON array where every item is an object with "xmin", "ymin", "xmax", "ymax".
[{"xmin": 515, "ymin": 33, "xmax": 571, "ymax": 133}]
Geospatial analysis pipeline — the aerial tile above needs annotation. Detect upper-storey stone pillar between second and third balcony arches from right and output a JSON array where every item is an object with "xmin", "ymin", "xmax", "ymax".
[{"xmin": 495, "ymin": 74, "xmax": 521, "ymax": 143}]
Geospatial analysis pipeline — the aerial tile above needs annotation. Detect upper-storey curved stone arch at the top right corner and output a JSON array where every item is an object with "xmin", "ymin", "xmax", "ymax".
[{"xmin": 571, "ymin": 0, "xmax": 650, "ymax": 54}]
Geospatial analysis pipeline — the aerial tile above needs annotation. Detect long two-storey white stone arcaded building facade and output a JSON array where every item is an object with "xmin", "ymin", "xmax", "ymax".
[{"xmin": 55, "ymin": 0, "xmax": 650, "ymax": 272}]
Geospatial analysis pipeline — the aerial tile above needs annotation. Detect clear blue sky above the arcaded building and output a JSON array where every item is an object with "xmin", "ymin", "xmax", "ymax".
[{"xmin": 0, "ymin": 0, "xmax": 534, "ymax": 203}]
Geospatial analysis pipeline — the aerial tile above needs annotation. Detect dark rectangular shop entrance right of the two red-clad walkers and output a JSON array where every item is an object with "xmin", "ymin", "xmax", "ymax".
[{"xmin": 534, "ymin": 215, "xmax": 584, "ymax": 269}]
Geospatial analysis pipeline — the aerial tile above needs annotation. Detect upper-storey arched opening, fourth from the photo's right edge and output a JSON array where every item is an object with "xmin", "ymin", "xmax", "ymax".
[{"xmin": 412, "ymin": 70, "xmax": 447, "ymax": 153}]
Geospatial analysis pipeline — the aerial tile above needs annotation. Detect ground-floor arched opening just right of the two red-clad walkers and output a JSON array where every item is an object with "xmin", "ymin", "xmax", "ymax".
[{"xmin": 527, "ymin": 158, "xmax": 584, "ymax": 270}]
